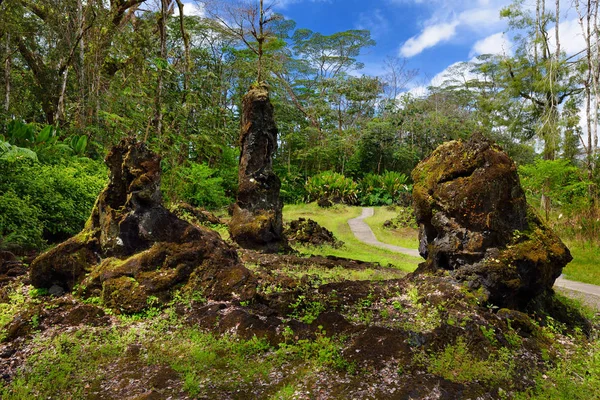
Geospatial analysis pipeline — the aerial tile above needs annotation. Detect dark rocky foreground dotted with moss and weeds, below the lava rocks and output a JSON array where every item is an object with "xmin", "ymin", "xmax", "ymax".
[{"xmin": 0, "ymin": 245, "xmax": 590, "ymax": 399}]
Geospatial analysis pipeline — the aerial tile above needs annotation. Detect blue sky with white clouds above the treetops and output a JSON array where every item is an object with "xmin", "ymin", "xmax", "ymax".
[{"xmin": 186, "ymin": 0, "xmax": 584, "ymax": 93}]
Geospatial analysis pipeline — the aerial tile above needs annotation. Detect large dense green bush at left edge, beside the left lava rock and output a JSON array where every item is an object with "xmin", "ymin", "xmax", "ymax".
[{"xmin": 0, "ymin": 158, "xmax": 107, "ymax": 247}]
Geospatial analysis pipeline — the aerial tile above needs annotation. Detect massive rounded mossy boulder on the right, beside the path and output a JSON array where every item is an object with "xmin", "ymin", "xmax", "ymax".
[{"xmin": 412, "ymin": 134, "xmax": 572, "ymax": 308}]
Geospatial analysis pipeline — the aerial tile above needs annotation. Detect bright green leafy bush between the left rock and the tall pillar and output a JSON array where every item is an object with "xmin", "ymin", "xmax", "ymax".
[{"xmin": 164, "ymin": 163, "xmax": 232, "ymax": 209}]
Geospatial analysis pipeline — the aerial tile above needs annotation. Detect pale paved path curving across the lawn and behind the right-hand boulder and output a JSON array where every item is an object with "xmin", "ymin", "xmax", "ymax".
[{"xmin": 348, "ymin": 207, "xmax": 600, "ymax": 309}]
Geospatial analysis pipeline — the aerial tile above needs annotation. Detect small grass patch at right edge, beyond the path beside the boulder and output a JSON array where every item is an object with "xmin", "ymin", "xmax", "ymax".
[{"xmin": 563, "ymin": 242, "xmax": 600, "ymax": 285}]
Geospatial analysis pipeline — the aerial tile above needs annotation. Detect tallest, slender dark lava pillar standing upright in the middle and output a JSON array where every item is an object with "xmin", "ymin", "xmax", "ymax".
[{"xmin": 229, "ymin": 83, "xmax": 289, "ymax": 253}]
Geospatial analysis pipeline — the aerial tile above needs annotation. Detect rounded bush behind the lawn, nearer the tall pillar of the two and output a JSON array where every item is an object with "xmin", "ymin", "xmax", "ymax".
[{"xmin": 306, "ymin": 171, "xmax": 358, "ymax": 204}]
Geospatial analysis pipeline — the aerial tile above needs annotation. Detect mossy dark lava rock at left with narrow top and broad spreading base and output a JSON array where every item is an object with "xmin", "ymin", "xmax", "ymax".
[{"xmin": 30, "ymin": 139, "xmax": 256, "ymax": 313}]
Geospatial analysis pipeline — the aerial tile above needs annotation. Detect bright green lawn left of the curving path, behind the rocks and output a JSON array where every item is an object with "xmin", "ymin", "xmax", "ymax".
[{"xmin": 283, "ymin": 203, "xmax": 419, "ymax": 271}]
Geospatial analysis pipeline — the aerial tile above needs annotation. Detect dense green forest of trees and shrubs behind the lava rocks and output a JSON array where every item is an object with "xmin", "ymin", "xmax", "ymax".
[{"xmin": 0, "ymin": 0, "xmax": 600, "ymax": 250}]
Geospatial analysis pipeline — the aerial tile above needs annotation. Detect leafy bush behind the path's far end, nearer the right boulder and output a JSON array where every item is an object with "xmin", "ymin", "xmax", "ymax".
[{"xmin": 359, "ymin": 171, "xmax": 412, "ymax": 206}]
